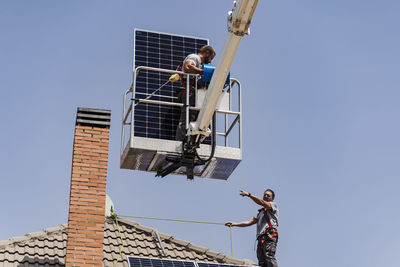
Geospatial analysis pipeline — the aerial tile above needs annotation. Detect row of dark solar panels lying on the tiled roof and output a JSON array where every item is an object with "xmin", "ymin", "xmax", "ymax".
[{"xmin": 127, "ymin": 256, "xmax": 253, "ymax": 267}]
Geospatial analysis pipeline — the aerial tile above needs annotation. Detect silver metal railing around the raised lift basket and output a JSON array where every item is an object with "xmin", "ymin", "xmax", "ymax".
[{"xmin": 120, "ymin": 66, "xmax": 242, "ymax": 155}]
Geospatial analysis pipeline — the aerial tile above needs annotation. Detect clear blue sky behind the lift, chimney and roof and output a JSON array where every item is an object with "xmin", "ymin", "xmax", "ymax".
[{"xmin": 0, "ymin": 0, "xmax": 400, "ymax": 267}]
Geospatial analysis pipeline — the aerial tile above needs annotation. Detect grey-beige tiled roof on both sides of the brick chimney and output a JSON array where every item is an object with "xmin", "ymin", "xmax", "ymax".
[{"xmin": 0, "ymin": 218, "xmax": 255, "ymax": 267}]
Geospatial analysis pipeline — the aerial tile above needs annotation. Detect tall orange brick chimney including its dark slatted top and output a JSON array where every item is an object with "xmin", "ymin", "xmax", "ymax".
[{"xmin": 65, "ymin": 108, "xmax": 111, "ymax": 266}]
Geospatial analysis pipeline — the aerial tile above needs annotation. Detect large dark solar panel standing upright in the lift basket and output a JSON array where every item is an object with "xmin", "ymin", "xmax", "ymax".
[{"xmin": 134, "ymin": 29, "xmax": 208, "ymax": 140}]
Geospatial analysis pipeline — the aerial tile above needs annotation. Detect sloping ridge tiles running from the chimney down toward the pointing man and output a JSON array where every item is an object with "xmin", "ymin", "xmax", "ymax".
[{"xmin": 106, "ymin": 217, "xmax": 254, "ymax": 265}]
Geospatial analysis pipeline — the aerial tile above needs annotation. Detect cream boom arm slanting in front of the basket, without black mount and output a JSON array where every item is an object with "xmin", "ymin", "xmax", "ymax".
[{"xmin": 190, "ymin": 0, "xmax": 258, "ymax": 135}]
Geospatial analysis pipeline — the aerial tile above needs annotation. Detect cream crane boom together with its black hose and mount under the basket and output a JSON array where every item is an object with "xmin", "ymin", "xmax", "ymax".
[{"xmin": 156, "ymin": 0, "xmax": 258, "ymax": 179}]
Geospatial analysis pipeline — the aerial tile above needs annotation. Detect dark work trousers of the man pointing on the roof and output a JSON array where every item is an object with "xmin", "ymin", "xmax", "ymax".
[{"xmin": 257, "ymin": 236, "xmax": 278, "ymax": 267}]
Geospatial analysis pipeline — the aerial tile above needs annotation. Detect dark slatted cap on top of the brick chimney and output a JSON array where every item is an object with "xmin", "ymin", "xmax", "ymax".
[{"xmin": 75, "ymin": 107, "xmax": 111, "ymax": 128}]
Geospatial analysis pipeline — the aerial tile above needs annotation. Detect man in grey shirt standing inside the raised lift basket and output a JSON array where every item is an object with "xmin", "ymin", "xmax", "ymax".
[{"xmin": 175, "ymin": 45, "xmax": 215, "ymax": 141}]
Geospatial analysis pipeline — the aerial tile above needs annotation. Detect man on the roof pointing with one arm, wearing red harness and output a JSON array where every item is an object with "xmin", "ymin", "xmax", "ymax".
[{"xmin": 225, "ymin": 189, "xmax": 279, "ymax": 267}]
